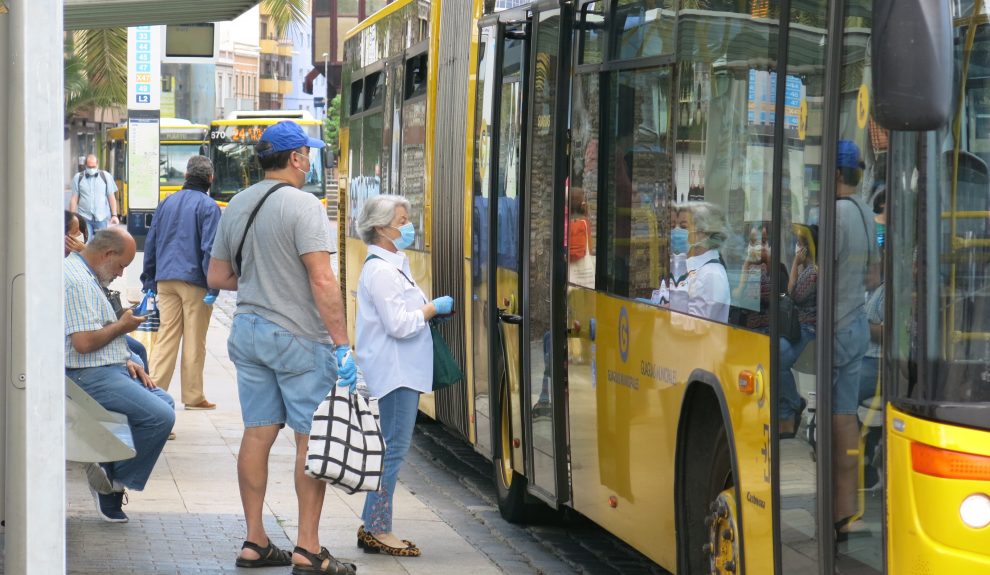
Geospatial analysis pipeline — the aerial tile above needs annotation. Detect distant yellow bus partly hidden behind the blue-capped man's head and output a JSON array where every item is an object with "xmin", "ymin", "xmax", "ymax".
[{"xmin": 210, "ymin": 110, "xmax": 327, "ymax": 207}]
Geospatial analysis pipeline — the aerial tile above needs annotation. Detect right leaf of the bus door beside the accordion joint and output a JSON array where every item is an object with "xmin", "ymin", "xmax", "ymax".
[{"xmin": 520, "ymin": 0, "xmax": 571, "ymax": 507}]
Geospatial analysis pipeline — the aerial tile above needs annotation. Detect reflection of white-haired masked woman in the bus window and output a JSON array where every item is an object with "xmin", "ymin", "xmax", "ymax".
[{"xmin": 670, "ymin": 202, "xmax": 731, "ymax": 322}]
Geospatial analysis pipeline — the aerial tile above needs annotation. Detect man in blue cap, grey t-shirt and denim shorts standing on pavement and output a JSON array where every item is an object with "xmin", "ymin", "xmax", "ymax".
[{"xmin": 207, "ymin": 121, "xmax": 356, "ymax": 574}]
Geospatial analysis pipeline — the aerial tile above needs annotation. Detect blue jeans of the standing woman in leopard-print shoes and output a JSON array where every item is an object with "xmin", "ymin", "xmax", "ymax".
[{"xmin": 361, "ymin": 387, "xmax": 419, "ymax": 534}]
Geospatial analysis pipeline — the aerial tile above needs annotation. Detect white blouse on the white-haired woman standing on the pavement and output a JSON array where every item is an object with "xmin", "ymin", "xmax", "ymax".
[{"xmin": 355, "ymin": 246, "xmax": 433, "ymax": 398}]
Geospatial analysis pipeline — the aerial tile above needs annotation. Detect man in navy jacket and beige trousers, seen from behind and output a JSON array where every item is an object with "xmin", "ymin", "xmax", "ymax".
[{"xmin": 141, "ymin": 156, "xmax": 220, "ymax": 409}]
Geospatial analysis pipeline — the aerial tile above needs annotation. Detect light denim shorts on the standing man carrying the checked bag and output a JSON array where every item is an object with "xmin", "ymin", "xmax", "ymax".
[{"xmin": 227, "ymin": 314, "xmax": 337, "ymax": 433}]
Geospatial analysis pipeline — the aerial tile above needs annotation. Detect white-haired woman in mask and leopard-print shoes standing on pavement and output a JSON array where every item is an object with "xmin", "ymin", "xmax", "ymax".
[{"xmin": 357, "ymin": 195, "xmax": 454, "ymax": 557}]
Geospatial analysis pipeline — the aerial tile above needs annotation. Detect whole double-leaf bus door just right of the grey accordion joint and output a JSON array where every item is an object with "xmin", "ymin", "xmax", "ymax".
[{"xmin": 472, "ymin": 2, "xmax": 569, "ymax": 521}]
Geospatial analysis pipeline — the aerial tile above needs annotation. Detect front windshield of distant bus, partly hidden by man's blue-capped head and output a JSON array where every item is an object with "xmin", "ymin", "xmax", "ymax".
[{"xmin": 210, "ymin": 125, "xmax": 324, "ymax": 202}]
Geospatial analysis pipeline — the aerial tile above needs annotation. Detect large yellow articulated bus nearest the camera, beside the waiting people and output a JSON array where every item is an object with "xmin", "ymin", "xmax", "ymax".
[{"xmin": 339, "ymin": 0, "xmax": 990, "ymax": 575}]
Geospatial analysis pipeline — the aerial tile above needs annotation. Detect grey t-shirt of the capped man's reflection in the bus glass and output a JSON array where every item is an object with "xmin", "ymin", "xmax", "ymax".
[{"xmin": 835, "ymin": 196, "xmax": 879, "ymax": 328}]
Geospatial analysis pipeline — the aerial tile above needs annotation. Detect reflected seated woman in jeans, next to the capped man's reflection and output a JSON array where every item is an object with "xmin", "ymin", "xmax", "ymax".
[{"xmin": 779, "ymin": 224, "xmax": 818, "ymax": 439}]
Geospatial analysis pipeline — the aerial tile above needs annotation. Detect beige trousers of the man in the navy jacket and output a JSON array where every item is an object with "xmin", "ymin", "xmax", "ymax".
[{"xmin": 150, "ymin": 280, "xmax": 213, "ymax": 405}]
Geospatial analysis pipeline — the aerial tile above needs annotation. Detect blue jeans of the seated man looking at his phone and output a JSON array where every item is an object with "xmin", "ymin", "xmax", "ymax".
[{"xmin": 65, "ymin": 365, "xmax": 175, "ymax": 491}]
